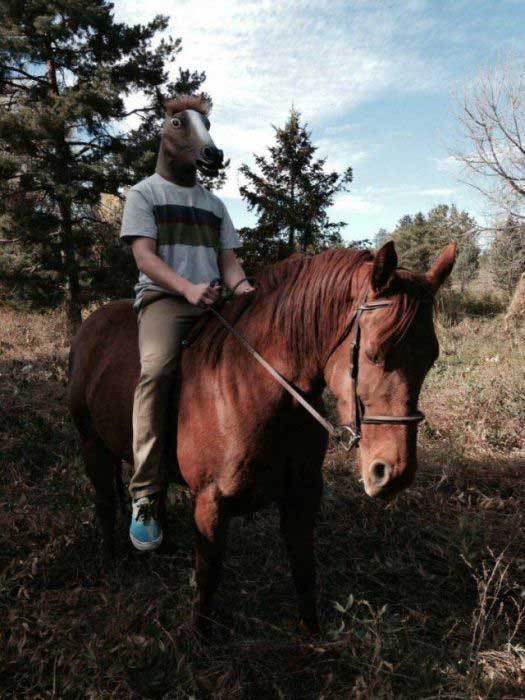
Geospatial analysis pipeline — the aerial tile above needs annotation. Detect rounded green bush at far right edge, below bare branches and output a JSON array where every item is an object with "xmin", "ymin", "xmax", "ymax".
[{"xmin": 489, "ymin": 218, "xmax": 525, "ymax": 295}]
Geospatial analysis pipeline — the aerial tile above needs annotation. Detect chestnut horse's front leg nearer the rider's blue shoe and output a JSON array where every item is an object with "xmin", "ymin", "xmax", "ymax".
[{"xmin": 193, "ymin": 484, "xmax": 228, "ymax": 633}]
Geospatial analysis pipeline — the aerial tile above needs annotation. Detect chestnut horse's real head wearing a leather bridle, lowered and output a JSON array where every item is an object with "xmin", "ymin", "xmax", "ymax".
[{"xmin": 325, "ymin": 242, "xmax": 456, "ymax": 497}]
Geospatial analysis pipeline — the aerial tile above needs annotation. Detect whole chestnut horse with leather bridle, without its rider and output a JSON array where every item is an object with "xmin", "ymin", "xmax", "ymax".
[{"xmin": 70, "ymin": 243, "xmax": 455, "ymax": 631}]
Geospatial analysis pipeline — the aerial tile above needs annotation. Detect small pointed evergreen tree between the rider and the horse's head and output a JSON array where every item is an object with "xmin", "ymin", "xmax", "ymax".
[{"xmin": 240, "ymin": 108, "xmax": 352, "ymax": 261}]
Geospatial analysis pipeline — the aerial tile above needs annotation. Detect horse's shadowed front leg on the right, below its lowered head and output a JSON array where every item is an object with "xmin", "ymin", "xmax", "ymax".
[{"xmin": 280, "ymin": 473, "xmax": 322, "ymax": 634}]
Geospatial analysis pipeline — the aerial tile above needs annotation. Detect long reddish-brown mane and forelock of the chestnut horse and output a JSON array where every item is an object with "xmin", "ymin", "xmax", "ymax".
[{"xmin": 189, "ymin": 248, "xmax": 431, "ymax": 366}]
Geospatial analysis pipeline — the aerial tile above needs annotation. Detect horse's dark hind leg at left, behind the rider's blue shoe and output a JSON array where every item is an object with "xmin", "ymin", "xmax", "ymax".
[{"xmin": 82, "ymin": 436, "xmax": 118, "ymax": 567}]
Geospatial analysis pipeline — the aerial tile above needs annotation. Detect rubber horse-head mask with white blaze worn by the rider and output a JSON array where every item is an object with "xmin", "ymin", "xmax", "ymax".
[{"xmin": 157, "ymin": 95, "xmax": 224, "ymax": 176}]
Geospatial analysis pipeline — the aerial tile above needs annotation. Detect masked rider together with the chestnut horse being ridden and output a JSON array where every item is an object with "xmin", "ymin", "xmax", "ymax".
[{"xmin": 68, "ymin": 97, "xmax": 456, "ymax": 632}]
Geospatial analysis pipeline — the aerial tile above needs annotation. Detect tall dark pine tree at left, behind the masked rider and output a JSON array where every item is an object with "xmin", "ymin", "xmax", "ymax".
[{"xmin": 0, "ymin": 0, "xmax": 209, "ymax": 330}]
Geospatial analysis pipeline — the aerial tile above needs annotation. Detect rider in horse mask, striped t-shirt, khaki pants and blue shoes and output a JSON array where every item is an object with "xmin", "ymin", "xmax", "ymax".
[{"xmin": 120, "ymin": 95, "xmax": 252, "ymax": 551}]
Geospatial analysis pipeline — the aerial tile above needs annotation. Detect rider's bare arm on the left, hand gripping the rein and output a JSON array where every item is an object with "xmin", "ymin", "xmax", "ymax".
[{"xmin": 131, "ymin": 236, "xmax": 220, "ymax": 307}]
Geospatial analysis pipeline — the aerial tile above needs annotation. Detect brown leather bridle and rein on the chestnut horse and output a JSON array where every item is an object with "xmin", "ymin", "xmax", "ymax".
[{"xmin": 202, "ymin": 280, "xmax": 425, "ymax": 451}]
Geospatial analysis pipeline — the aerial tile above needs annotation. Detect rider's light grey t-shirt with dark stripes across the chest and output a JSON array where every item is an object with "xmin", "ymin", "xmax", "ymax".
[{"xmin": 120, "ymin": 173, "xmax": 241, "ymax": 308}]
